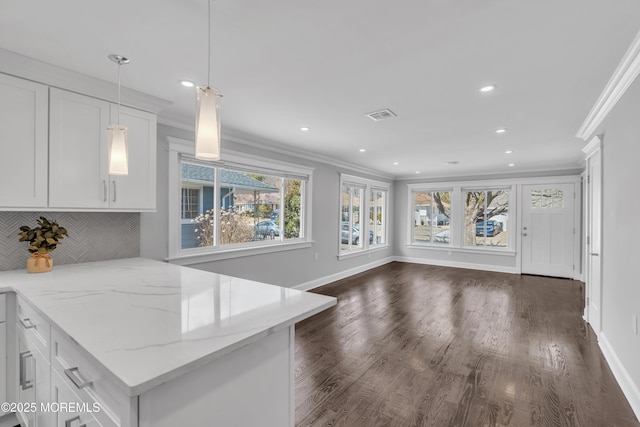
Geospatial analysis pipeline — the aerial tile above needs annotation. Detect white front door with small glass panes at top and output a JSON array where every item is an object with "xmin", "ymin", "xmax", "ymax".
[{"xmin": 522, "ymin": 183, "xmax": 575, "ymax": 278}]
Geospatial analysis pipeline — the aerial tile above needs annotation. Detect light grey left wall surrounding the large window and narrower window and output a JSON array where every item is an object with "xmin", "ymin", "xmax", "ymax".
[{"xmin": 140, "ymin": 125, "xmax": 393, "ymax": 288}]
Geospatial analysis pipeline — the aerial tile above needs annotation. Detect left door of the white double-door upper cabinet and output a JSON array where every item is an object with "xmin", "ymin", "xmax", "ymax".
[{"xmin": 49, "ymin": 88, "xmax": 110, "ymax": 208}]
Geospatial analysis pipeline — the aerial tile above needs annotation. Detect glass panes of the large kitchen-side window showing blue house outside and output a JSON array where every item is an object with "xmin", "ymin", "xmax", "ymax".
[{"xmin": 180, "ymin": 158, "xmax": 306, "ymax": 250}]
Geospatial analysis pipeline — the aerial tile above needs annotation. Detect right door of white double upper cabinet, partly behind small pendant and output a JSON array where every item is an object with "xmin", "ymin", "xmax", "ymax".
[{"xmin": 109, "ymin": 104, "xmax": 157, "ymax": 210}]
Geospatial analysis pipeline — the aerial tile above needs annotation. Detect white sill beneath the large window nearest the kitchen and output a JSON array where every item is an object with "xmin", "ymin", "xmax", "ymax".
[{"xmin": 165, "ymin": 240, "xmax": 313, "ymax": 265}]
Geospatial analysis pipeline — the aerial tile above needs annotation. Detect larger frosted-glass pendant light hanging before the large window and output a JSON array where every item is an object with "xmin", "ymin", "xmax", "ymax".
[{"xmin": 195, "ymin": 0, "xmax": 222, "ymax": 160}]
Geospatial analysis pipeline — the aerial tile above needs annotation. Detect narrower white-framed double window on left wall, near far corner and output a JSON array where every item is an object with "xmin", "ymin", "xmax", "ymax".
[{"xmin": 339, "ymin": 175, "xmax": 389, "ymax": 255}]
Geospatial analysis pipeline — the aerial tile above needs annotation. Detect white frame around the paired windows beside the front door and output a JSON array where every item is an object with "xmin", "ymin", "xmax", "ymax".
[{"xmin": 405, "ymin": 180, "xmax": 518, "ymax": 256}]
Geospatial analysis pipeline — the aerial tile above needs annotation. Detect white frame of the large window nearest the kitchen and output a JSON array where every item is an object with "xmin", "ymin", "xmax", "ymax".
[{"xmin": 166, "ymin": 137, "xmax": 314, "ymax": 265}]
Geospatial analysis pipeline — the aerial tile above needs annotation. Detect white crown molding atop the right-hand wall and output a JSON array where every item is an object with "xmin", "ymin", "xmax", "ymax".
[{"xmin": 576, "ymin": 33, "xmax": 640, "ymax": 141}]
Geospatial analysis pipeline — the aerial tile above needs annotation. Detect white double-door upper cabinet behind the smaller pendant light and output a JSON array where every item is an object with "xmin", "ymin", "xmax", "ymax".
[{"xmin": 49, "ymin": 88, "xmax": 157, "ymax": 211}]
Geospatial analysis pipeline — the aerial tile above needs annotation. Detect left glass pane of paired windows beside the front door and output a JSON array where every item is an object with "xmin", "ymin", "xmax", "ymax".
[{"xmin": 411, "ymin": 191, "xmax": 451, "ymax": 245}]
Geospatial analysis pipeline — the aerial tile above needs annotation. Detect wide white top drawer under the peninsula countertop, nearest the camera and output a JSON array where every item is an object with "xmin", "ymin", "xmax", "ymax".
[{"xmin": 51, "ymin": 328, "xmax": 135, "ymax": 427}]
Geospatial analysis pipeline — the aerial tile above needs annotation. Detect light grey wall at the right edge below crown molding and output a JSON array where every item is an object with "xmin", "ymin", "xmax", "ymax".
[{"xmin": 602, "ymin": 74, "xmax": 640, "ymax": 416}]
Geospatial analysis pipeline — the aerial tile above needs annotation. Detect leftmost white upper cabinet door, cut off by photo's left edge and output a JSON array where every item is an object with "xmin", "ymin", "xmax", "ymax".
[{"xmin": 0, "ymin": 74, "xmax": 48, "ymax": 209}]
